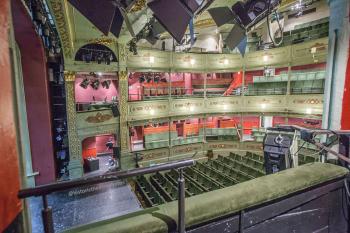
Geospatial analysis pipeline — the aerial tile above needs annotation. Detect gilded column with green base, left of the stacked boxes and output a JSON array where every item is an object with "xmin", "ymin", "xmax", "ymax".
[{"xmin": 64, "ymin": 72, "xmax": 84, "ymax": 179}]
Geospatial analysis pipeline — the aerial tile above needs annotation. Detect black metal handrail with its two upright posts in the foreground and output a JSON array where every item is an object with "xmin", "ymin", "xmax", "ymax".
[{"xmin": 18, "ymin": 159, "xmax": 195, "ymax": 233}]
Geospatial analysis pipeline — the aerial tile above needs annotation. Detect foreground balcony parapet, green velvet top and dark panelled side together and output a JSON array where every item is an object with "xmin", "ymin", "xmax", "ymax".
[{"xmin": 66, "ymin": 163, "xmax": 348, "ymax": 233}]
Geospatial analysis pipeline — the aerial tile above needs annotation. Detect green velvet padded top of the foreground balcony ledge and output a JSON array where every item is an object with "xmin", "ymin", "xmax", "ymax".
[{"xmin": 66, "ymin": 163, "xmax": 348, "ymax": 233}]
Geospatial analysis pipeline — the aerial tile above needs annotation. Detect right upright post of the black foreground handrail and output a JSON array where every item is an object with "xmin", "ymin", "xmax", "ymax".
[{"xmin": 178, "ymin": 168, "xmax": 185, "ymax": 233}]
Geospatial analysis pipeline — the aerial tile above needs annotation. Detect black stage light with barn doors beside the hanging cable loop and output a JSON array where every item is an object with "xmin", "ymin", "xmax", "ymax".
[{"xmin": 208, "ymin": 0, "xmax": 281, "ymax": 50}]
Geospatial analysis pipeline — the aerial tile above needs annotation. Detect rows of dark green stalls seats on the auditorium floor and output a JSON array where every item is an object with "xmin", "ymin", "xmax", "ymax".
[{"xmin": 135, "ymin": 151, "xmax": 316, "ymax": 207}]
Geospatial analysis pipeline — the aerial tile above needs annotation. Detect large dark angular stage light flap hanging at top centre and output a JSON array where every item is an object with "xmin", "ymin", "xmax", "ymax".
[{"xmin": 147, "ymin": 0, "xmax": 214, "ymax": 43}]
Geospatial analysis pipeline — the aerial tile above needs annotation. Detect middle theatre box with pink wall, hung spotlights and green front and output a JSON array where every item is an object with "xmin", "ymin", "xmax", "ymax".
[{"xmin": 74, "ymin": 73, "xmax": 119, "ymax": 140}]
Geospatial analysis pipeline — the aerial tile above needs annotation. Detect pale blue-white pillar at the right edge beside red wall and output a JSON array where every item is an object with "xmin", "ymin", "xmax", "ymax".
[{"xmin": 322, "ymin": 0, "xmax": 350, "ymax": 130}]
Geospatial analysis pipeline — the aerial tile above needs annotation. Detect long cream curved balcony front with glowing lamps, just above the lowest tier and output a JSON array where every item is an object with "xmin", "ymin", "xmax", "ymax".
[{"xmin": 128, "ymin": 94, "xmax": 323, "ymax": 121}]
